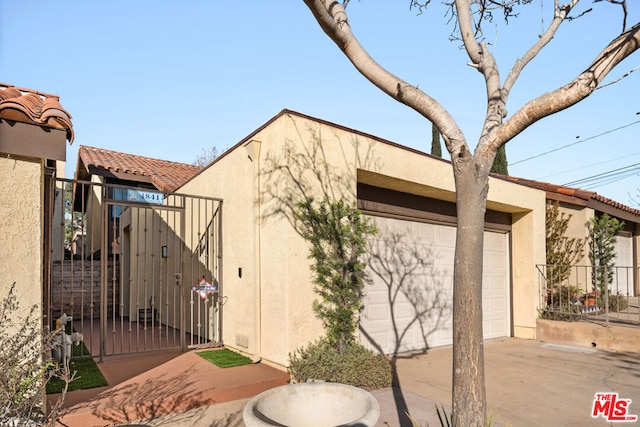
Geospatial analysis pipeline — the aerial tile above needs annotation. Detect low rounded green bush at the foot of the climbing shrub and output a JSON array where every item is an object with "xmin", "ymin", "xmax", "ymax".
[{"xmin": 289, "ymin": 339, "xmax": 391, "ymax": 390}]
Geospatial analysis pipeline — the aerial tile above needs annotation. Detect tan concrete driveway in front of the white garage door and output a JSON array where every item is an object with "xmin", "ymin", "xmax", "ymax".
[{"xmin": 390, "ymin": 338, "xmax": 640, "ymax": 426}]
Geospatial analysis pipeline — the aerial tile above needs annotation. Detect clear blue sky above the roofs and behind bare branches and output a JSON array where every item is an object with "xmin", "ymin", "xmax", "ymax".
[{"xmin": 0, "ymin": 0, "xmax": 640, "ymax": 205}]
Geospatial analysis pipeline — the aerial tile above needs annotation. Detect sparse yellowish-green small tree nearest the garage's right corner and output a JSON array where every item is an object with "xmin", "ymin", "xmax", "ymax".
[{"xmin": 546, "ymin": 202, "xmax": 587, "ymax": 284}]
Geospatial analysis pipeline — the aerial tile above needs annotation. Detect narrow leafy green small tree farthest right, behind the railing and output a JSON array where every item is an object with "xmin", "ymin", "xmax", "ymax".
[{"xmin": 587, "ymin": 214, "xmax": 624, "ymax": 295}]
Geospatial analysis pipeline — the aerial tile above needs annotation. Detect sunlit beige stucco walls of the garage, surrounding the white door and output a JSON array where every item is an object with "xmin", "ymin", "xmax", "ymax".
[{"xmin": 180, "ymin": 114, "xmax": 545, "ymax": 365}]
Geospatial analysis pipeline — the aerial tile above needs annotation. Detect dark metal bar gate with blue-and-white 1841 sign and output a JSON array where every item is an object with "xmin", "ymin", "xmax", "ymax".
[{"xmin": 44, "ymin": 179, "xmax": 222, "ymax": 359}]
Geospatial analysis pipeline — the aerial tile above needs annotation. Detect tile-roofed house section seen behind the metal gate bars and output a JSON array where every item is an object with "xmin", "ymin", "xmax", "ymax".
[{"xmin": 69, "ymin": 146, "xmax": 219, "ymax": 355}]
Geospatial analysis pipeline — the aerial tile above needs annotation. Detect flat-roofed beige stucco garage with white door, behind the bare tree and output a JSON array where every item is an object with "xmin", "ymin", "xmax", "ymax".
[{"xmin": 179, "ymin": 110, "xmax": 545, "ymax": 366}]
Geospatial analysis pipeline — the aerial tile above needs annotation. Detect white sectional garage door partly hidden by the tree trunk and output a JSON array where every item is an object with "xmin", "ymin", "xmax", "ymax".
[{"xmin": 360, "ymin": 217, "xmax": 510, "ymax": 354}]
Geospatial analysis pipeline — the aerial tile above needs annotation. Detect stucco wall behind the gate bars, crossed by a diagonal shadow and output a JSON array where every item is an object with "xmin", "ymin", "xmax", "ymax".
[{"xmin": 118, "ymin": 201, "xmax": 218, "ymax": 344}]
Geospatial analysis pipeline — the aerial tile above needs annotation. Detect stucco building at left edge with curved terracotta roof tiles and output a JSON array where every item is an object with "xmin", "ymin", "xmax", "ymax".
[{"xmin": 0, "ymin": 83, "xmax": 74, "ymax": 332}]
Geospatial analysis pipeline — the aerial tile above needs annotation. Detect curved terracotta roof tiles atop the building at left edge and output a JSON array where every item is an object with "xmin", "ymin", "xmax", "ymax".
[{"xmin": 0, "ymin": 83, "xmax": 74, "ymax": 143}]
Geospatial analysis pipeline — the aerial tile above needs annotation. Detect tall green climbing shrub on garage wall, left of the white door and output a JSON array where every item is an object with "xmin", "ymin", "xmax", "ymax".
[{"xmin": 295, "ymin": 197, "xmax": 376, "ymax": 353}]
